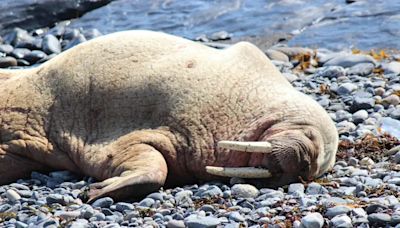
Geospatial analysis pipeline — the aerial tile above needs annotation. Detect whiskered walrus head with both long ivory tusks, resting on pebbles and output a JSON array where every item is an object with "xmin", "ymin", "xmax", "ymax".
[{"xmin": 206, "ymin": 125, "xmax": 338, "ymax": 187}]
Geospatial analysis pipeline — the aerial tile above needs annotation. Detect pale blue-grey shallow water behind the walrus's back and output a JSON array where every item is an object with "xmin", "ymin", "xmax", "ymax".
[{"xmin": 68, "ymin": 0, "xmax": 400, "ymax": 49}]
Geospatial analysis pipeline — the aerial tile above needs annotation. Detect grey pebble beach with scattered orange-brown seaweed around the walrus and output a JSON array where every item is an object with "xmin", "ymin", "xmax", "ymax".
[{"xmin": 0, "ymin": 3, "xmax": 400, "ymax": 228}]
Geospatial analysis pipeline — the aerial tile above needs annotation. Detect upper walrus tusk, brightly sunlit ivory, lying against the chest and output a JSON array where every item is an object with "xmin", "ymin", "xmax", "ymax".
[{"xmin": 218, "ymin": 141, "xmax": 272, "ymax": 153}]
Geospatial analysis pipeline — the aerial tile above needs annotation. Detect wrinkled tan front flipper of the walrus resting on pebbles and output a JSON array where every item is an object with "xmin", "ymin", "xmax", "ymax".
[{"xmin": 85, "ymin": 130, "xmax": 173, "ymax": 201}]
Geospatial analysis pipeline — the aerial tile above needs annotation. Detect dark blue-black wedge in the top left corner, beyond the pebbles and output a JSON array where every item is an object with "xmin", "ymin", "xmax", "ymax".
[{"xmin": 0, "ymin": 0, "xmax": 111, "ymax": 34}]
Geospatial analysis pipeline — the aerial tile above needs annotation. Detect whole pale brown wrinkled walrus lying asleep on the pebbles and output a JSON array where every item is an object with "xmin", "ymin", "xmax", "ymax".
[{"xmin": 0, "ymin": 31, "xmax": 338, "ymax": 201}]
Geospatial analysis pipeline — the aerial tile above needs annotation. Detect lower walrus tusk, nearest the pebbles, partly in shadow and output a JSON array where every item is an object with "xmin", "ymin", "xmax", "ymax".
[{"xmin": 206, "ymin": 166, "xmax": 272, "ymax": 178}]
